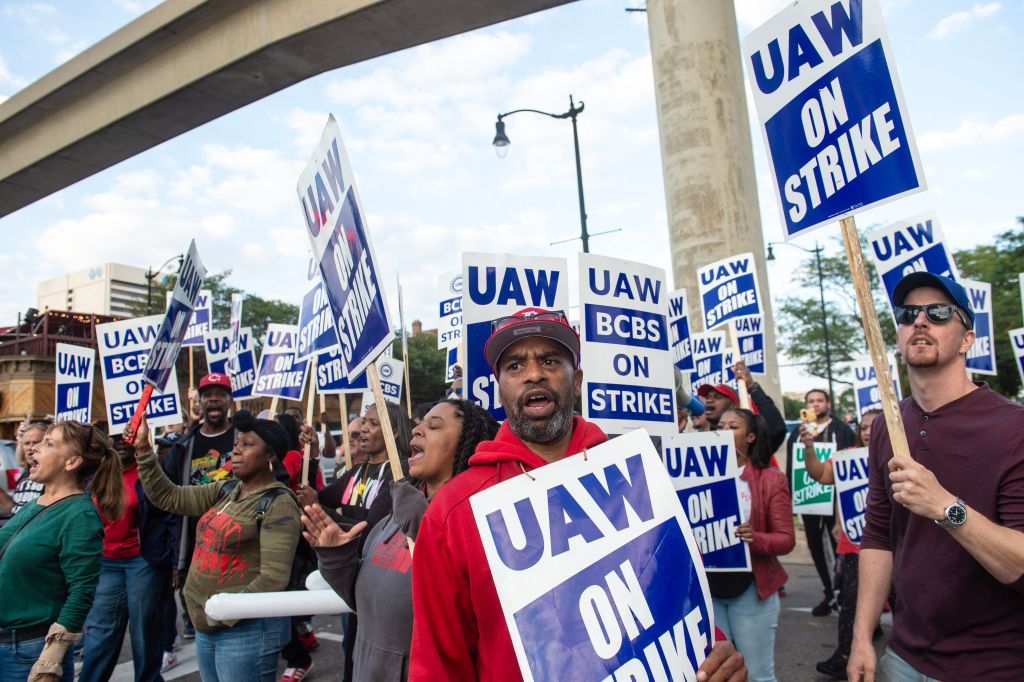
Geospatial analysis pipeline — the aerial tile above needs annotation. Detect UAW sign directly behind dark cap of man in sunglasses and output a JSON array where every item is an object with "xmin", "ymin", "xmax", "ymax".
[{"xmin": 867, "ymin": 212, "xmax": 959, "ymax": 305}]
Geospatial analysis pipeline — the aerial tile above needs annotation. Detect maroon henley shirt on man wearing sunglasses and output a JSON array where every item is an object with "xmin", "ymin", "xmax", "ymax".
[{"xmin": 861, "ymin": 383, "xmax": 1024, "ymax": 681}]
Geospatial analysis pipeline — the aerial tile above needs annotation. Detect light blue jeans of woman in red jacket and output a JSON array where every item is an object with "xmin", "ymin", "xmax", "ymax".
[{"xmin": 714, "ymin": 583, "xmax": 779, "ymax": 682}]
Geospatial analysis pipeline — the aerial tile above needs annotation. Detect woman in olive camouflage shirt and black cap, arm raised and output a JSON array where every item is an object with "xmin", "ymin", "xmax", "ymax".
[{"xmin": 135, "ymin": 410, "xmax": 301, "ymax": 682}]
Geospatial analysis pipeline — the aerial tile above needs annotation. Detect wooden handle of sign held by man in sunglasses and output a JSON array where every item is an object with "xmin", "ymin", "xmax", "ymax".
[{"xmin": 840, "ymin": 216, "xmax": 910, "ymax": 457}]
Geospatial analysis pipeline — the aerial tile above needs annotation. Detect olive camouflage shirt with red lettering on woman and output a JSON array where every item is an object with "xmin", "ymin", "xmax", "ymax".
[{"xmin": 138, "ymin": 451, "xmax": 301, "ymax": 632}]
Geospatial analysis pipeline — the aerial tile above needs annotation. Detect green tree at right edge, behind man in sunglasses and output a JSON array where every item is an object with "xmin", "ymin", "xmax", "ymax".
[{"xmin": 953, "ymin": 217, "xmax": 1024, "ymax": 397}]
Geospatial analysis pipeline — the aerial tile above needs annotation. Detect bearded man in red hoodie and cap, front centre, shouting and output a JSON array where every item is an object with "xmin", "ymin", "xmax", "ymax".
[{"xmin": 409, "ymin": 308, "xmax": 746, "ymax": 682}]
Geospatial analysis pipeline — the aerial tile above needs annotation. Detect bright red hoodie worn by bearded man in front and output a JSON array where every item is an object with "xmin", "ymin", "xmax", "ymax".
[{"xmin": 409, "ymin": 417, "xmax": 608, "ymax": 682}]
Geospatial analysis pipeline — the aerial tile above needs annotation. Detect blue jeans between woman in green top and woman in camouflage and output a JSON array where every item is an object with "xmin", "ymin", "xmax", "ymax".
[{"xmin": 79, "ymin": 556, "xmax": 169, "ymax": 682}]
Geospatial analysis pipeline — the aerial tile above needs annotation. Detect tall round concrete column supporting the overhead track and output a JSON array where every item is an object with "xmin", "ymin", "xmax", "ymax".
[{"xmin": 647, "ymin": 0, "xmax": 782, "ymax": 410}]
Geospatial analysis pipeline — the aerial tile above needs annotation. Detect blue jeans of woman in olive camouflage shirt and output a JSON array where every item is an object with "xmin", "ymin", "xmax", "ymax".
[{"xmin": 196, "ymin": 617, "xmax": 292, "ymax": 682}]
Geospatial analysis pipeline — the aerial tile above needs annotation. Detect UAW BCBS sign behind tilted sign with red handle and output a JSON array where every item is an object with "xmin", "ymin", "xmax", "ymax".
[{"xmin": 96, "ymin": 315, "xmax": 182, "ymax": 435}]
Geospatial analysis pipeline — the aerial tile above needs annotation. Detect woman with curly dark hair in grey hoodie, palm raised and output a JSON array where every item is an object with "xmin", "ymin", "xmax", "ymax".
[{"xmin": 302, "ymin": 400, "xmax": 498, "ymax": 680}]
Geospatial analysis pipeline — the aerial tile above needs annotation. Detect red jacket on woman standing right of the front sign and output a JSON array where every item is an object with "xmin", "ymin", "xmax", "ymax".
[{"xmin": 739, "ymin": 464, "xmax": 797, "ymax": 599}]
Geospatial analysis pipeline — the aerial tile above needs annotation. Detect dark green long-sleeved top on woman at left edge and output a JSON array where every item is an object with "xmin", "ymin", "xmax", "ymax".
[{"xmin": 0, "ymin": 495, "xmax": 103, "ymax": 632}]
